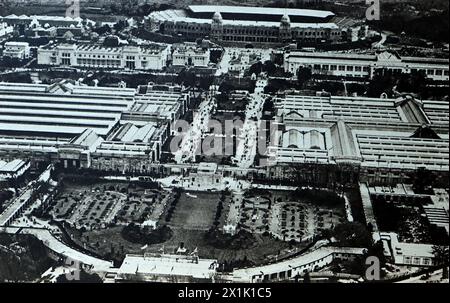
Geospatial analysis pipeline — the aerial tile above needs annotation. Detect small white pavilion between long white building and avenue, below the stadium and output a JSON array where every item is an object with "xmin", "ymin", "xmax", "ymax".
[{"xmin": 172, "ymin": 43, "xmax": 210, "ymax": 67}]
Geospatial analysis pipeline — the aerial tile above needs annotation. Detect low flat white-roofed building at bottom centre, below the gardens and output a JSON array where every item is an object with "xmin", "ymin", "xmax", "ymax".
[{"xmin": 115, "ymin": 254, "xmax": 218, "ymax": 283}]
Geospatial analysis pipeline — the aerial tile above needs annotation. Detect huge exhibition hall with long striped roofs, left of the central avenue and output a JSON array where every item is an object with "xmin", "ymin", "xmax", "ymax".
[{"xmin": 0, "ymin": 81, "xmax": 190, "ymax": 173}]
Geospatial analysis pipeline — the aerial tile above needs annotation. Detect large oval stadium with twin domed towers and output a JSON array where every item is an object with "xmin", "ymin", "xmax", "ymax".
[{"xmin": 146, "ymin": 5, "xmax": 341, "ymax": 44}]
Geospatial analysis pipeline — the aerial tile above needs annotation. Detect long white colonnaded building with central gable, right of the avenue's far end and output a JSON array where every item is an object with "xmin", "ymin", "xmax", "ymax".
[{"xmin": 284, "ymin": 51, "xmax": 449, "ymax": 81}]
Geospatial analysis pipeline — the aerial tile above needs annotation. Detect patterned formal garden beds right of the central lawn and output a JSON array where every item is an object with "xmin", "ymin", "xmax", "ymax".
[{"xmin": 238, "ymin": 188, "xmax": 346, "ymax": 242}]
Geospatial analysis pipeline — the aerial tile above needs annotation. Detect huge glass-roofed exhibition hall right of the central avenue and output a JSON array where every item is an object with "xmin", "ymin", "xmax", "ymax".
[{"xmin": 261, "ymin": 94, "xmax": 449, "ymax": 186}]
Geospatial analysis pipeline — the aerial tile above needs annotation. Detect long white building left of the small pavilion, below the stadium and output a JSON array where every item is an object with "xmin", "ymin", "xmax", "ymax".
[{"xmin": 38, "ymin": 44, "xmax": 170, "ymax": 70}]
